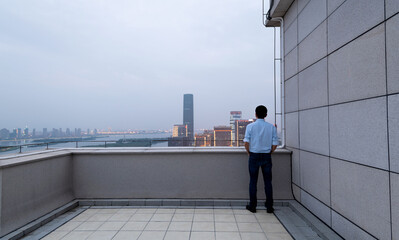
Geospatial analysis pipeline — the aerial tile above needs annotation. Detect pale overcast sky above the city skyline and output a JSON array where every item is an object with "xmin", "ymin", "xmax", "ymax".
[{"xmin": 0, "ymin": 0, "xmax": 274, "ymax": 129}]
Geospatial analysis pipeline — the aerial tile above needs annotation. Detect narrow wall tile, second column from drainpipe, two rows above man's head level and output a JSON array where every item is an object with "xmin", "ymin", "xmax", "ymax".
[{"xmin": 298, "ymin": 21, "xmax": 327, "ymax": 71}]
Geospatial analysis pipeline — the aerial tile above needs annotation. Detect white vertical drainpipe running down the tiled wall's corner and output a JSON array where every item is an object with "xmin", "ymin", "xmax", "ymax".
[{"xmin": 271, "ymin": 17, "xmax": 286, "ymax": 148}]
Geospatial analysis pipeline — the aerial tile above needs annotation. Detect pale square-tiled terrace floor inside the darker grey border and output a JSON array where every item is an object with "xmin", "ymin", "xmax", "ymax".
[{"xmin": 39, "ymin": 208, "xmax": 292, "ymax": 240}]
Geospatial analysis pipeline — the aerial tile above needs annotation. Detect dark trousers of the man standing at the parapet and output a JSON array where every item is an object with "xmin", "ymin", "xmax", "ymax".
[{"xmin": 248, "ymin": 153, "xmax": 273, "ymax": 208}]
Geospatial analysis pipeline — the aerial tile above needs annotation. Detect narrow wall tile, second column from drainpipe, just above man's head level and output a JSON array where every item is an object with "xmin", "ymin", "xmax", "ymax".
[{"xmin": 298, "ymin": 58, "xmax": 328, "ymax": 109}]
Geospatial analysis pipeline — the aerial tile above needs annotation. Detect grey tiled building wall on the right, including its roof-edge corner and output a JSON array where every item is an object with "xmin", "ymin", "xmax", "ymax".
[{"xmin": 267, "ymin": 0, "xmax": 399, "ymax": 239}]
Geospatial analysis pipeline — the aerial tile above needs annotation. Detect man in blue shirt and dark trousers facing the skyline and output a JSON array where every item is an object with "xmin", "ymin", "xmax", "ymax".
[{"xmin": 244, "ymin": 105, "xmax": 278, "ymax": 213}]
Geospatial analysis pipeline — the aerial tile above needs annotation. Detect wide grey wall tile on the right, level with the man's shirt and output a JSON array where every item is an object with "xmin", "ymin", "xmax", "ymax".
[{"xmin": 330, "ymin": 97, "xmax": 388, "ymax": 170}]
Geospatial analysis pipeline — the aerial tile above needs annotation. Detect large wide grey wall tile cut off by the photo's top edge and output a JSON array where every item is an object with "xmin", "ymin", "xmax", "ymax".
[{"xmin": 328, "ymin": 0, "xmax": 384, "ymax": 53}]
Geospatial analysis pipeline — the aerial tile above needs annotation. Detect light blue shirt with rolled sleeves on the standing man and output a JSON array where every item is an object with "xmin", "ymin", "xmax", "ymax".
[{"xmin": 244, "ymin": 119, "xmax": 278, "ymax": 153}]
